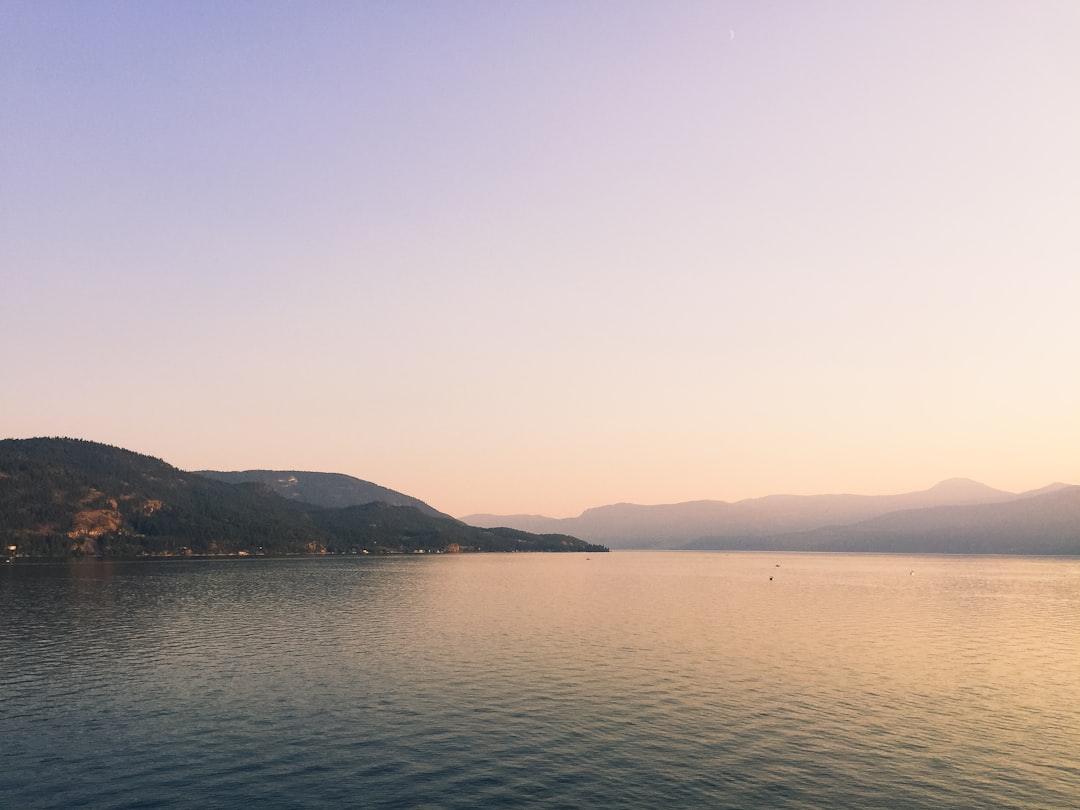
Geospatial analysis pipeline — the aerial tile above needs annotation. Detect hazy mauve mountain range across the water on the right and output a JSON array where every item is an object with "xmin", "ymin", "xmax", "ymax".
[{"xmin": 463, "ymin": 478, "xmax": 1080, "ymax": 554}]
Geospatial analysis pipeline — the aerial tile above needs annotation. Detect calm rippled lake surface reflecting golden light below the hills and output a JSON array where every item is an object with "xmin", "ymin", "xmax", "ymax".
[{"xmin": 0, "ymin": 552, "xmax": 1080, "ymax": 808}]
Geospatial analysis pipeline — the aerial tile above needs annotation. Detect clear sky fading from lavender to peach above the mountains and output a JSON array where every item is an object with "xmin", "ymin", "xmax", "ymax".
[{"xmin": 0, "ymin": 0, "xmax": 1080, "ymax": 517}]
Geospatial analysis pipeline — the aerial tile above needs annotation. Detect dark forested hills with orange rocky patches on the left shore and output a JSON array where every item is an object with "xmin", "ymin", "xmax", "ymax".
[{"xmin": 0, "ymin": 438, "xmax": 606, "ymax": 559}]
